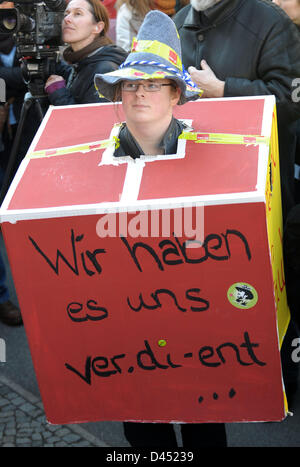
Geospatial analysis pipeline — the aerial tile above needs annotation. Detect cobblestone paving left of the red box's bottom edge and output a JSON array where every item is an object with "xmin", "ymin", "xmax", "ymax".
[{"xmin": 0, "ymin": 375, "xmax": 109, "ymax": 447}]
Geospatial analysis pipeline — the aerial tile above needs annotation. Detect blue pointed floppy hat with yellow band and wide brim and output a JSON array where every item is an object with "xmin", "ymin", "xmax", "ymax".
[{"xmin": 95, "ymin": 10, "xmax": 202, "ymax": 104}]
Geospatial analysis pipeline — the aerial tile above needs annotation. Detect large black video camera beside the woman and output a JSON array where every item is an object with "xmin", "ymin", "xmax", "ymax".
[{"xmin": 0, "ymin": 0, "xmax": 66, "ymax": 95}]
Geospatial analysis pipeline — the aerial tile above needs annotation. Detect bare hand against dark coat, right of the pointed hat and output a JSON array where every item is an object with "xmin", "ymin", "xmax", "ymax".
[{"xmin": 188, "ymin": 60, "xmax": 225, "ymax": 97}]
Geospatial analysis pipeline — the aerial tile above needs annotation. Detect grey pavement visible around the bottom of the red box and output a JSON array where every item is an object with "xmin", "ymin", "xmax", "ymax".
[{"xmin": 0, "ymin": 235, "xmax": 300, "ymax": 448}]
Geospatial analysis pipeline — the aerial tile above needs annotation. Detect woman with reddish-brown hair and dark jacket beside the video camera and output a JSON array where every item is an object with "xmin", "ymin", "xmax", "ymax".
[{"xmin": 45, "ymin": 0, "xmax": 127, "ymax": 105}]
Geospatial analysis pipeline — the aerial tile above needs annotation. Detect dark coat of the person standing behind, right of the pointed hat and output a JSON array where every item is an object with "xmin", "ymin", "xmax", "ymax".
[{"xmin": 174, "ymin": 0, "xmax": 300, "ymax": 121}]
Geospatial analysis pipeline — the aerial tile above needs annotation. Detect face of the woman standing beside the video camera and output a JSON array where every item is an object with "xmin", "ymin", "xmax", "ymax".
[{"xmin": 62, "ymin": 0, "xmax": 104, "ymax": 50}]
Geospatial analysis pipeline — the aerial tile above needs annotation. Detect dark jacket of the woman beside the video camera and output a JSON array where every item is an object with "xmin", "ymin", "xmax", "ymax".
[{"xmin": 49, "ymin": 45, "xmax": 127, "ymax": 105}]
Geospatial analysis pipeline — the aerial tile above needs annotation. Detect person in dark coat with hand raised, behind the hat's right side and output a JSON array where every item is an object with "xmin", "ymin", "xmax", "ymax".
[{"xmin": 174, "ymin": 0, "xmax": 300, "ymax": 227}]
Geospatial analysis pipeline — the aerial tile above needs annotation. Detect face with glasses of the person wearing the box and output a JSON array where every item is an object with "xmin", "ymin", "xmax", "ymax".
[{"xmin": 121, "ymin": 79, "xmax": 180, "ymax": 125}]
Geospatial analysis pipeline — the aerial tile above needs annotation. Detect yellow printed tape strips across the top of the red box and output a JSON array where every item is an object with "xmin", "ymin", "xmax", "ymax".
[{"xmin": 26, "ymin": 131, "xmax": 270, "ymax": 159}]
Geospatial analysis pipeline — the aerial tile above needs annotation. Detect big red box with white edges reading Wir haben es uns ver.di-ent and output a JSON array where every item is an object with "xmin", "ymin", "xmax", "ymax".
[{"xmin": 1, "ymin": 96, "xmax": 289, "ymax": 424}]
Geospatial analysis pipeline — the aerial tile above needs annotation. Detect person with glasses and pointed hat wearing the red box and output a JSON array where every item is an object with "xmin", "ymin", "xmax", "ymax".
[{"xmin": 95, "ymin": 10, "xmax": 227, "ymax": 448}]
